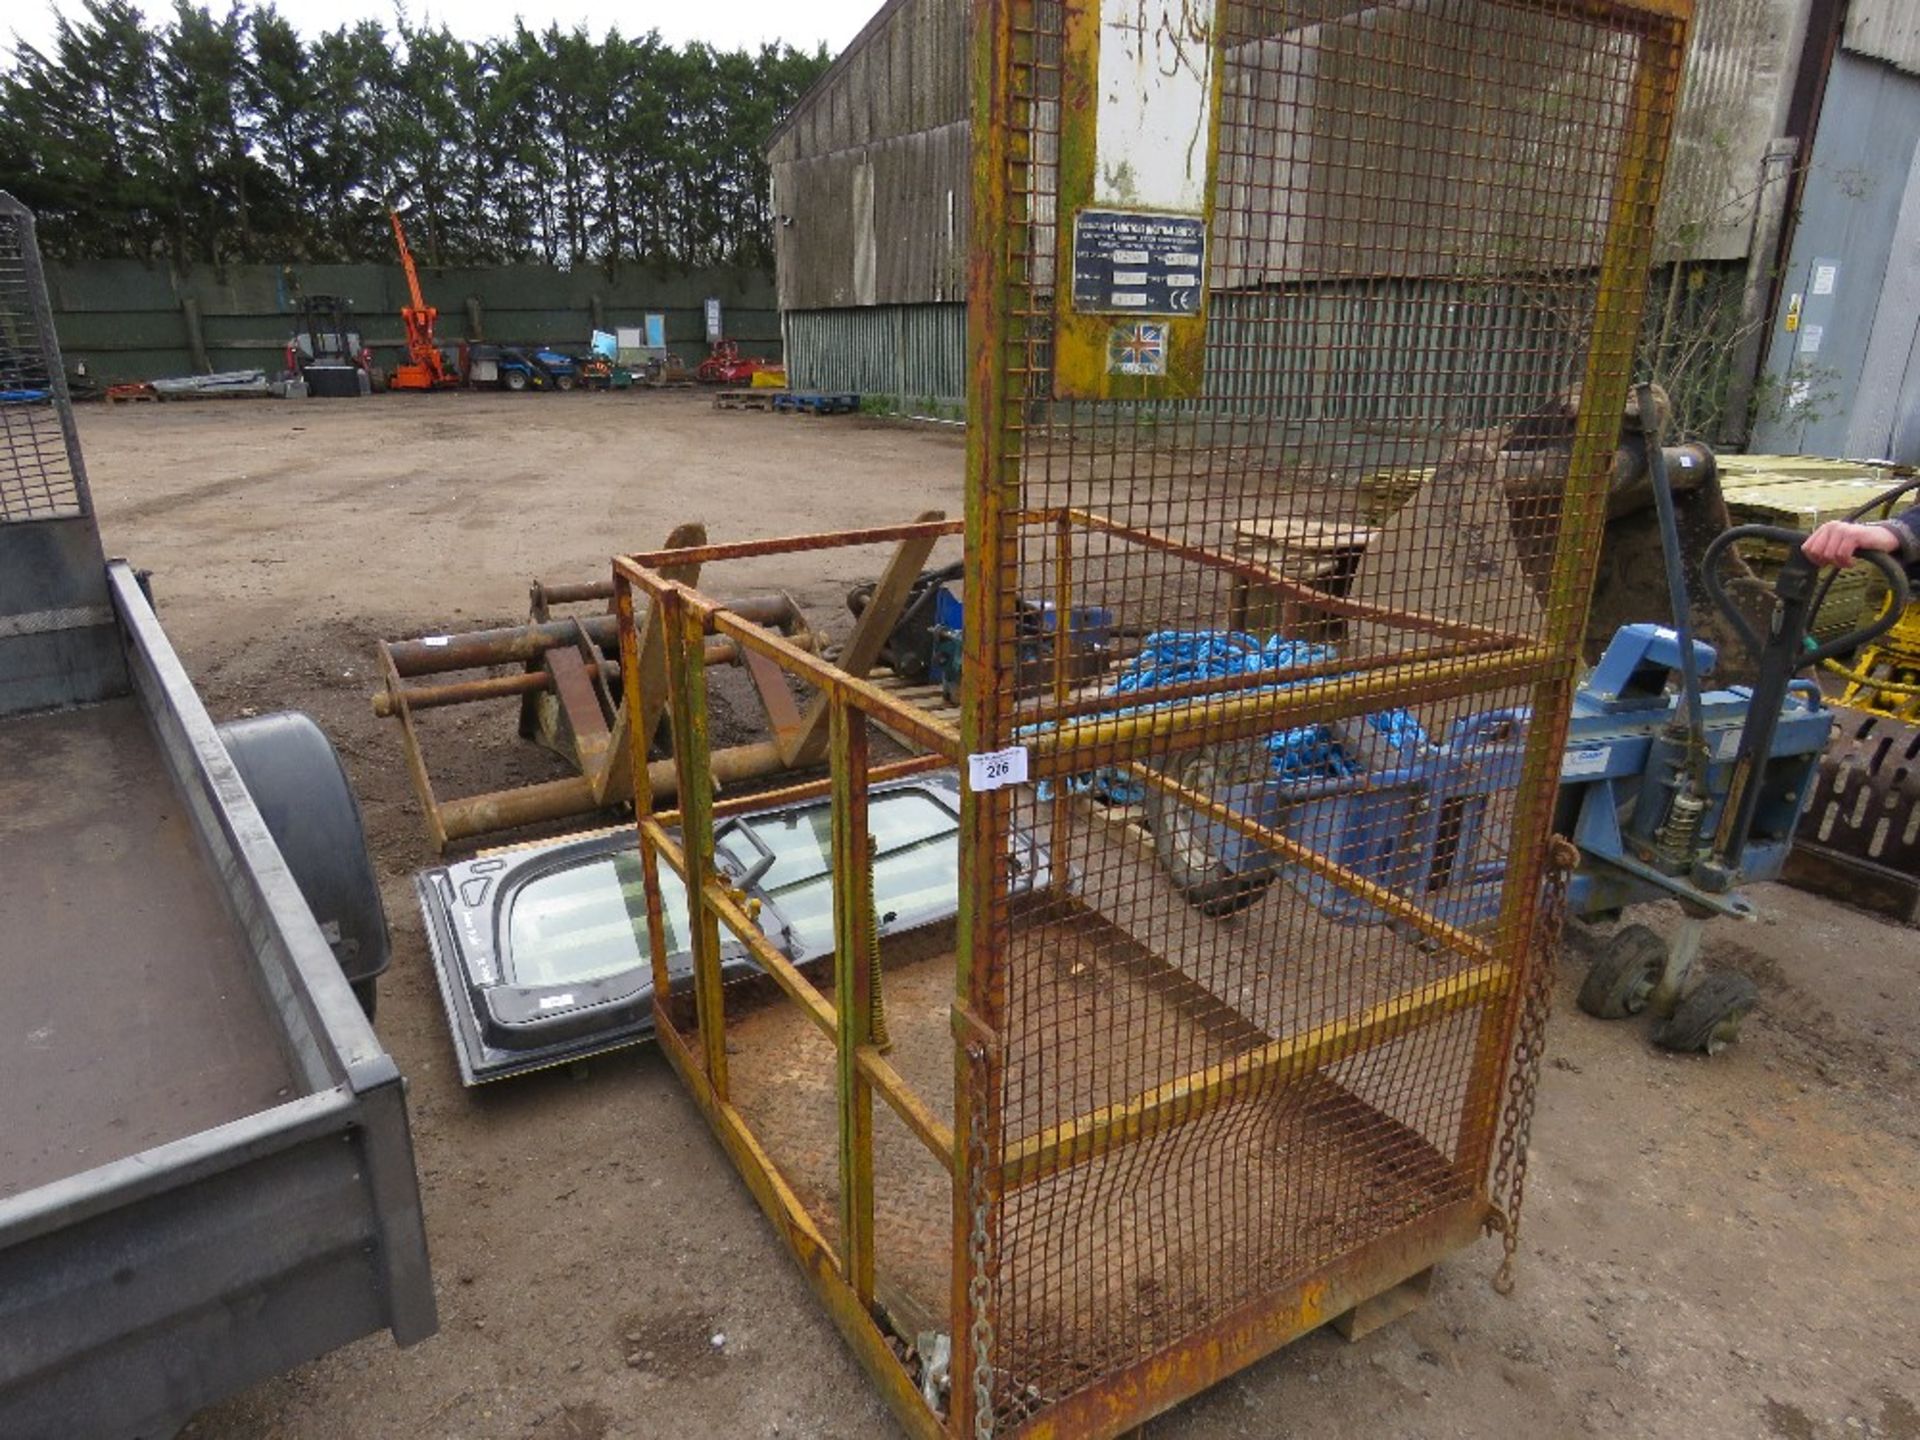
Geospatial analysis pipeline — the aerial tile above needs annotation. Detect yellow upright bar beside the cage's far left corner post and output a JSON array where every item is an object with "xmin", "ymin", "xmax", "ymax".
[{"xmin": 657, "ymin": 586, "xmax": 728, "ymax": 1100}]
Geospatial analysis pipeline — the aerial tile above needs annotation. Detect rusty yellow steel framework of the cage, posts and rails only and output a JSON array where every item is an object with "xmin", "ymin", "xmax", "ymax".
[{"xmin": 612, "ymin": 0, "xmax": 1690, "ymax": 1440}]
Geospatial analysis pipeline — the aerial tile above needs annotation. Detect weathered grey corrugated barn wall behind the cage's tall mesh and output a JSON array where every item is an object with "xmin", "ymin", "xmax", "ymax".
[{"xmin": 768, "ymin": 0, "xmax": 1797, "ymax": 430}]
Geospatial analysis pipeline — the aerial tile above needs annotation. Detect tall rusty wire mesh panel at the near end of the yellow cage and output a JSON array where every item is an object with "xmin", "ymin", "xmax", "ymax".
[{"xmin": 970, "ymin": 0, "xmax": 1680, "ymax": 1421}]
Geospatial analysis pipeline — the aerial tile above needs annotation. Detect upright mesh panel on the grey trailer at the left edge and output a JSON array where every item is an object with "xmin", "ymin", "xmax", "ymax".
[{"xmin": 0, "ymin": 194, "xmax": 86, "ymax": 524}]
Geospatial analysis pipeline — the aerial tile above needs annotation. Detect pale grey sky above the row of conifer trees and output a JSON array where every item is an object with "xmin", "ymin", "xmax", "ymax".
[{"xmin": 0, "ymin": 0, "xmax": 881, "ymax": 54}]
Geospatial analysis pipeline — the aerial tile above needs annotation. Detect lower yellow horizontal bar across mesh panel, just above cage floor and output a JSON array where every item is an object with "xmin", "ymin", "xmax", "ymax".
[{"xmin": 1000, "ymin": 964, "xmax": 1513, "ymax": 1188}]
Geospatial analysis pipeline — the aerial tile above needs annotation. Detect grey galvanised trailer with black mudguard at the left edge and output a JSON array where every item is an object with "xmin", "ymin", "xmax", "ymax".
[{"xmin": 0, "ymin": 194, "xmax": 436, "ymax": 1440}]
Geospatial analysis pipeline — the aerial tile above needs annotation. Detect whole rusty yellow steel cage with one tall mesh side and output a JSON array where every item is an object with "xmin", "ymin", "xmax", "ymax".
[{"xmin": 614, "ymin": 0, "xmax": 1686, "ymax": 1436}]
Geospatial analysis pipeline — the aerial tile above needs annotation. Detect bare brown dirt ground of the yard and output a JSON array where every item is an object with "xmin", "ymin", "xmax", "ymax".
[{"xmin": 67, "ymin": 396, "xmax": 1920, "ymax": 1440}]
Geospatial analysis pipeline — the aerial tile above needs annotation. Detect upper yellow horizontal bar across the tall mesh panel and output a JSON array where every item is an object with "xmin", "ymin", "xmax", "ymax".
[{"xmin": 1025, "ymin": 645, "xmax": 1574, "ymax": 780}]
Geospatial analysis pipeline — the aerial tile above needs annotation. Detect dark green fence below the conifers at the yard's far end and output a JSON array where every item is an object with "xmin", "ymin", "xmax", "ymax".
[{"xmin": 48, "ymin": 261, "xmax": 780, "ymax": 382}]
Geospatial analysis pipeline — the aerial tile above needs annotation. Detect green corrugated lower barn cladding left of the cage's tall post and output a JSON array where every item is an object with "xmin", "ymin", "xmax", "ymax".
[{"xmin": 781, "ymin": 303, "xmax": 966, "ymax": 419}]
